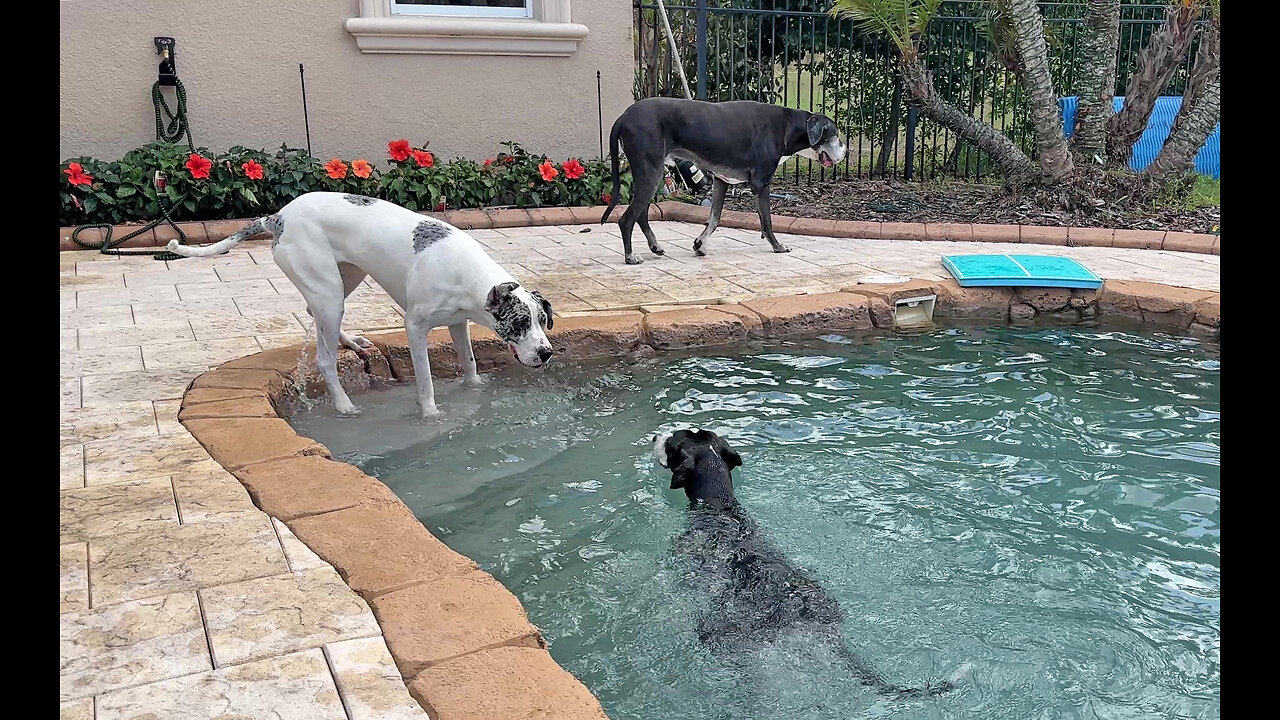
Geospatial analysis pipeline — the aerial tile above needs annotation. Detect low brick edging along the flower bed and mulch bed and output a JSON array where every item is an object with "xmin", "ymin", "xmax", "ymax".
[{"xmin": 58, "ymin": 201, "xmax": 1222, "ymax": 255}]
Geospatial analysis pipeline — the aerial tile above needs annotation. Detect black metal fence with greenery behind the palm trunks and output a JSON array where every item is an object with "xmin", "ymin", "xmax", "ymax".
[{"xmin": 634, "ymin": 0, "xmax": 1197, "ymax": 183}]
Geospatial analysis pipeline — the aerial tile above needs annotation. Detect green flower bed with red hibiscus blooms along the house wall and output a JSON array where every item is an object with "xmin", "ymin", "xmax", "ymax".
[{"xmin": 59, "ymin": 140, "xmax": 631, "ymax": 225}]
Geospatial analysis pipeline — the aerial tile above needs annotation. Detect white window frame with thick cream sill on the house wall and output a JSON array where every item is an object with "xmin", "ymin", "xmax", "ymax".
[{"xmin": 344, "ymin": 0, "xmax": 589, "ymax": 58}]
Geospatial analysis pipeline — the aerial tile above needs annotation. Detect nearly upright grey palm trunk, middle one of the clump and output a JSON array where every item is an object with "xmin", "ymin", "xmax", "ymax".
[{"xmin": 1073, "ymin": 0, "xmax": 1120, "ymax": 163}]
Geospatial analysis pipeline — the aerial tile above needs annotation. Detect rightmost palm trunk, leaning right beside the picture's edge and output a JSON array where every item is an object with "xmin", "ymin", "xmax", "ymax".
[{"xmin": 1143, "ymin": 18, "xmax": 1222, "ymax": 177}]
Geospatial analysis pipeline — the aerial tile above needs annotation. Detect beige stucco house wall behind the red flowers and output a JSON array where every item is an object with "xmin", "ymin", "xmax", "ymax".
[{"xmin": 58, "ymin": 0, "xmax": 632, "ymax": 161}]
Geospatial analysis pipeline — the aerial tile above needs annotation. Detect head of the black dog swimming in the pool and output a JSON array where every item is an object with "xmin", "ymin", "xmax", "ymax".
[{"xmin": 653, "ymin": 428, "xmax": 742, "ymax": 505}]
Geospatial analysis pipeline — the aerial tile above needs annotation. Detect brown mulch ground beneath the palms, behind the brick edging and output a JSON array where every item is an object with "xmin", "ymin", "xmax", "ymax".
[{"xmin": 724, "ymin": 179, "xmax": 1221, "ymax": 233}]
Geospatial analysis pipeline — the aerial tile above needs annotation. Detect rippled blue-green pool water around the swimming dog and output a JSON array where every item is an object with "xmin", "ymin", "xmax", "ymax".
[{"xmin": 293, "ymin": 327, "xmax": 1221, "ymax": 720}]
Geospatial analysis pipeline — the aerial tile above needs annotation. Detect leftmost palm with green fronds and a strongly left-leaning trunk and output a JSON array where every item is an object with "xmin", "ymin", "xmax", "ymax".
[{"xmin": 831, "ymin": 0, "xmax": 1036, "ymax": 179}]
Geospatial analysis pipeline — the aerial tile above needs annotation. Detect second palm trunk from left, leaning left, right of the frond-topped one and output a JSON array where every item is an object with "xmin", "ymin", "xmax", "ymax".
[{"xmin": 1006, "ymin": 0, "xmax": 1075, "ymax": 182}]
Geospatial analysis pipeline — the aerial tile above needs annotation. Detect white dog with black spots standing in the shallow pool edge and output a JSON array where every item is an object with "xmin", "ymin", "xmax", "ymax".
[{"xmin": 168, "ymin": 192, "xmax": 552, "ymax": 418}]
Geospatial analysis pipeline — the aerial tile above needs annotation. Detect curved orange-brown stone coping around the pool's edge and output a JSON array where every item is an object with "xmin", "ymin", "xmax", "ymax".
[{"xmin": 178, "ymin": 279, "xmax": 1220, "ymax": 720}]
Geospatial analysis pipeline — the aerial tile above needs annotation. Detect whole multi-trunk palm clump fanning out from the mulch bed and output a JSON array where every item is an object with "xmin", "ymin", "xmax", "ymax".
[{"xmin": 831, "ymin": 0, "xmax": 1222, "ymax": 188}]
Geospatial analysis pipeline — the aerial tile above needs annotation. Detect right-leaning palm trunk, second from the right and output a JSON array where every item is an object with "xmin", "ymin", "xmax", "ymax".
[{"xmin": 1107, "ymin": 0, "xmax": 1203, "ymax": 165}]
